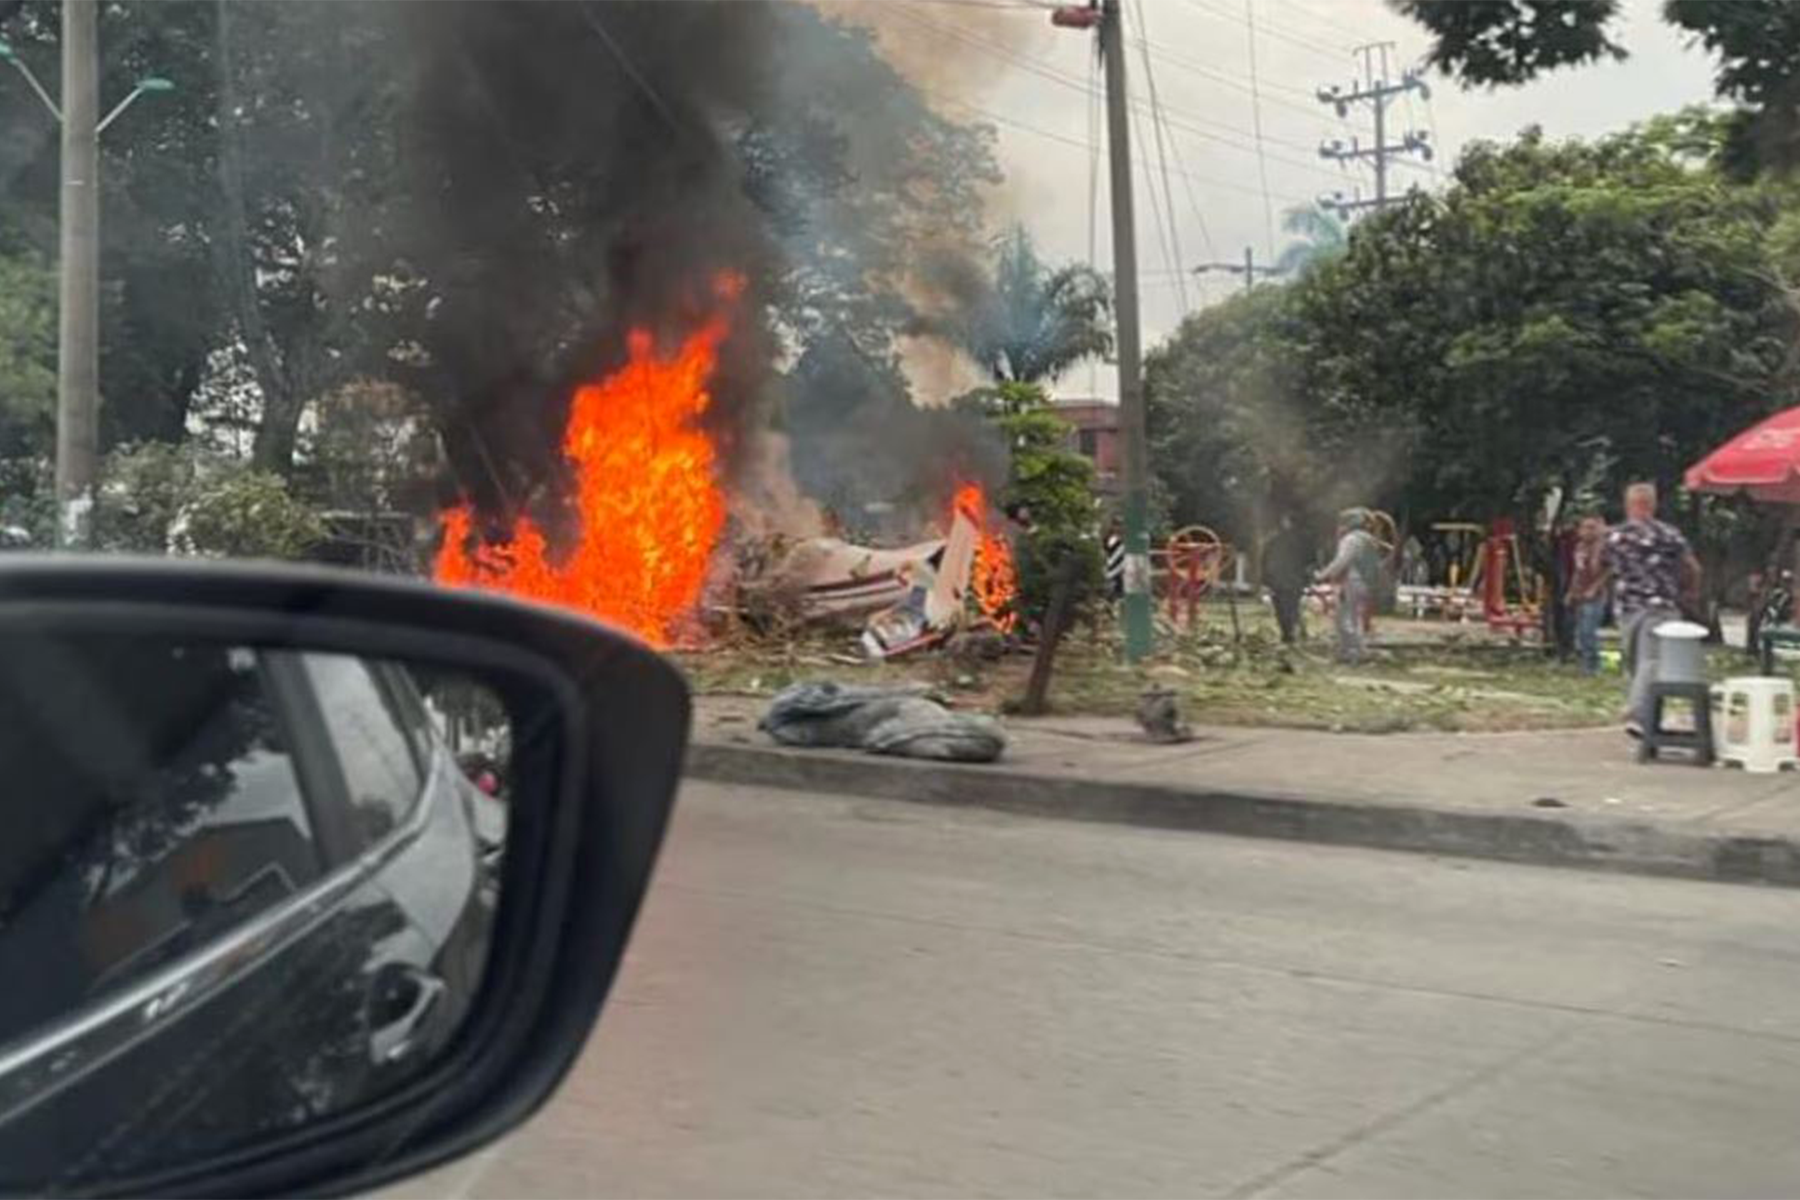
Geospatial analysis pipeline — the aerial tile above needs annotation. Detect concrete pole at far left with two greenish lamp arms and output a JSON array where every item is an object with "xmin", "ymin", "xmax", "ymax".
[{"xmin": 0, "ymin": 30, "xmax": 175, "ymax": 549}]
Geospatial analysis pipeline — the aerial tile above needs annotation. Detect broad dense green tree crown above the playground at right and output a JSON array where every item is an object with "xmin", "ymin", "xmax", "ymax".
[{"xmin": 1145, "ymin": 113, "xmax": 1800, "ymax": 545}]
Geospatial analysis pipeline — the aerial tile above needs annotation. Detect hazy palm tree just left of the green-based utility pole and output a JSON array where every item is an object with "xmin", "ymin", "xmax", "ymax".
[{"xmin": 947, "ymin": 227, "xmax": 1112, "ymax": 383}]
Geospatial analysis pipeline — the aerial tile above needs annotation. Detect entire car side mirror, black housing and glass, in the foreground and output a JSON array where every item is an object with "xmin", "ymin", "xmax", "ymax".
[{"xmin": 0, "ymin": 556, "xmax": 689, "ymax": 1198}]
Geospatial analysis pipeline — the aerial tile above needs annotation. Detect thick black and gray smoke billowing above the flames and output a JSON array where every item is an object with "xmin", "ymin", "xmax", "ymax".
[{"xmin": 398, "ymin": 0, "xmax": 1004, "ymax": 539}]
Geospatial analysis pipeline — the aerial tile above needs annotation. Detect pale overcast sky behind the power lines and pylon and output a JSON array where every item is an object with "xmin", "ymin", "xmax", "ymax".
[{"xmin": 842, "ymin": 0, "xmax": 1714, "ymax": 399}]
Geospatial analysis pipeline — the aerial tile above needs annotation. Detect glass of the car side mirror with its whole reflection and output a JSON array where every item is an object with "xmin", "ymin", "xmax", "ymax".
[{"xmin": 0, "ymin": 635, "xmax": 511, "ymax": 1191}]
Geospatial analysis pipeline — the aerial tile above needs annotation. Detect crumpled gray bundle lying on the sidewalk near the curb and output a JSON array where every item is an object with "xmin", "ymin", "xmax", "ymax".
[{"xmin": 760, "ymin": 684, "xmax": 1006, "ymax": 763}]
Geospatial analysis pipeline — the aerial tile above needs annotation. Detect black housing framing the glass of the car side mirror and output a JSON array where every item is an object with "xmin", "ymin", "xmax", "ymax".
[{"xmin": 0, "ymin": 556, "xmax": 689, "ymax": 1198}]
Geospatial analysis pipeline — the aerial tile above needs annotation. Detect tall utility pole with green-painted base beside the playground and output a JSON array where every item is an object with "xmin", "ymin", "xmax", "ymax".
[{"xmin": 1049, "ymin": 0, "xmax": 1154, "ymax": 662}]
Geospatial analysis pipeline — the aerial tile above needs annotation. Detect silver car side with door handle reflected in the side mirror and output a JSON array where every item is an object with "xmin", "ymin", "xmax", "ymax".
[{"xmin": 0, "ymin": 651, "xmax": 486, "ymax": 1187}]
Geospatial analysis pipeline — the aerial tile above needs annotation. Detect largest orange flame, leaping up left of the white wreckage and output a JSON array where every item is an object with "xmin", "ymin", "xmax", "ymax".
[{"xmin": 432, "ymin": 275, "xmax": 743, "ymax": 646}]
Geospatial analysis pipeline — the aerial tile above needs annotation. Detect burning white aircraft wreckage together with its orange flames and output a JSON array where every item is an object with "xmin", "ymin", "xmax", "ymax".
[{"xmin": 434, "ymin": 277, "xmax": 1017, "ymax": 658}]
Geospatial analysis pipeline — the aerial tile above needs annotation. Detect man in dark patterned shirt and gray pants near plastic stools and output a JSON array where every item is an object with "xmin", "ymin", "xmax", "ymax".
[{"xmin": 1602, "ymin": 484, "xmax": 1699, "ymax": 738}]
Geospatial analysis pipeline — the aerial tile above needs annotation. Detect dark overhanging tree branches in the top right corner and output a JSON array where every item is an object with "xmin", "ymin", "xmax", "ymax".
[{"xmin": 1391, "ymin": 0, "xmax": 1800, "ymax": 171}]
